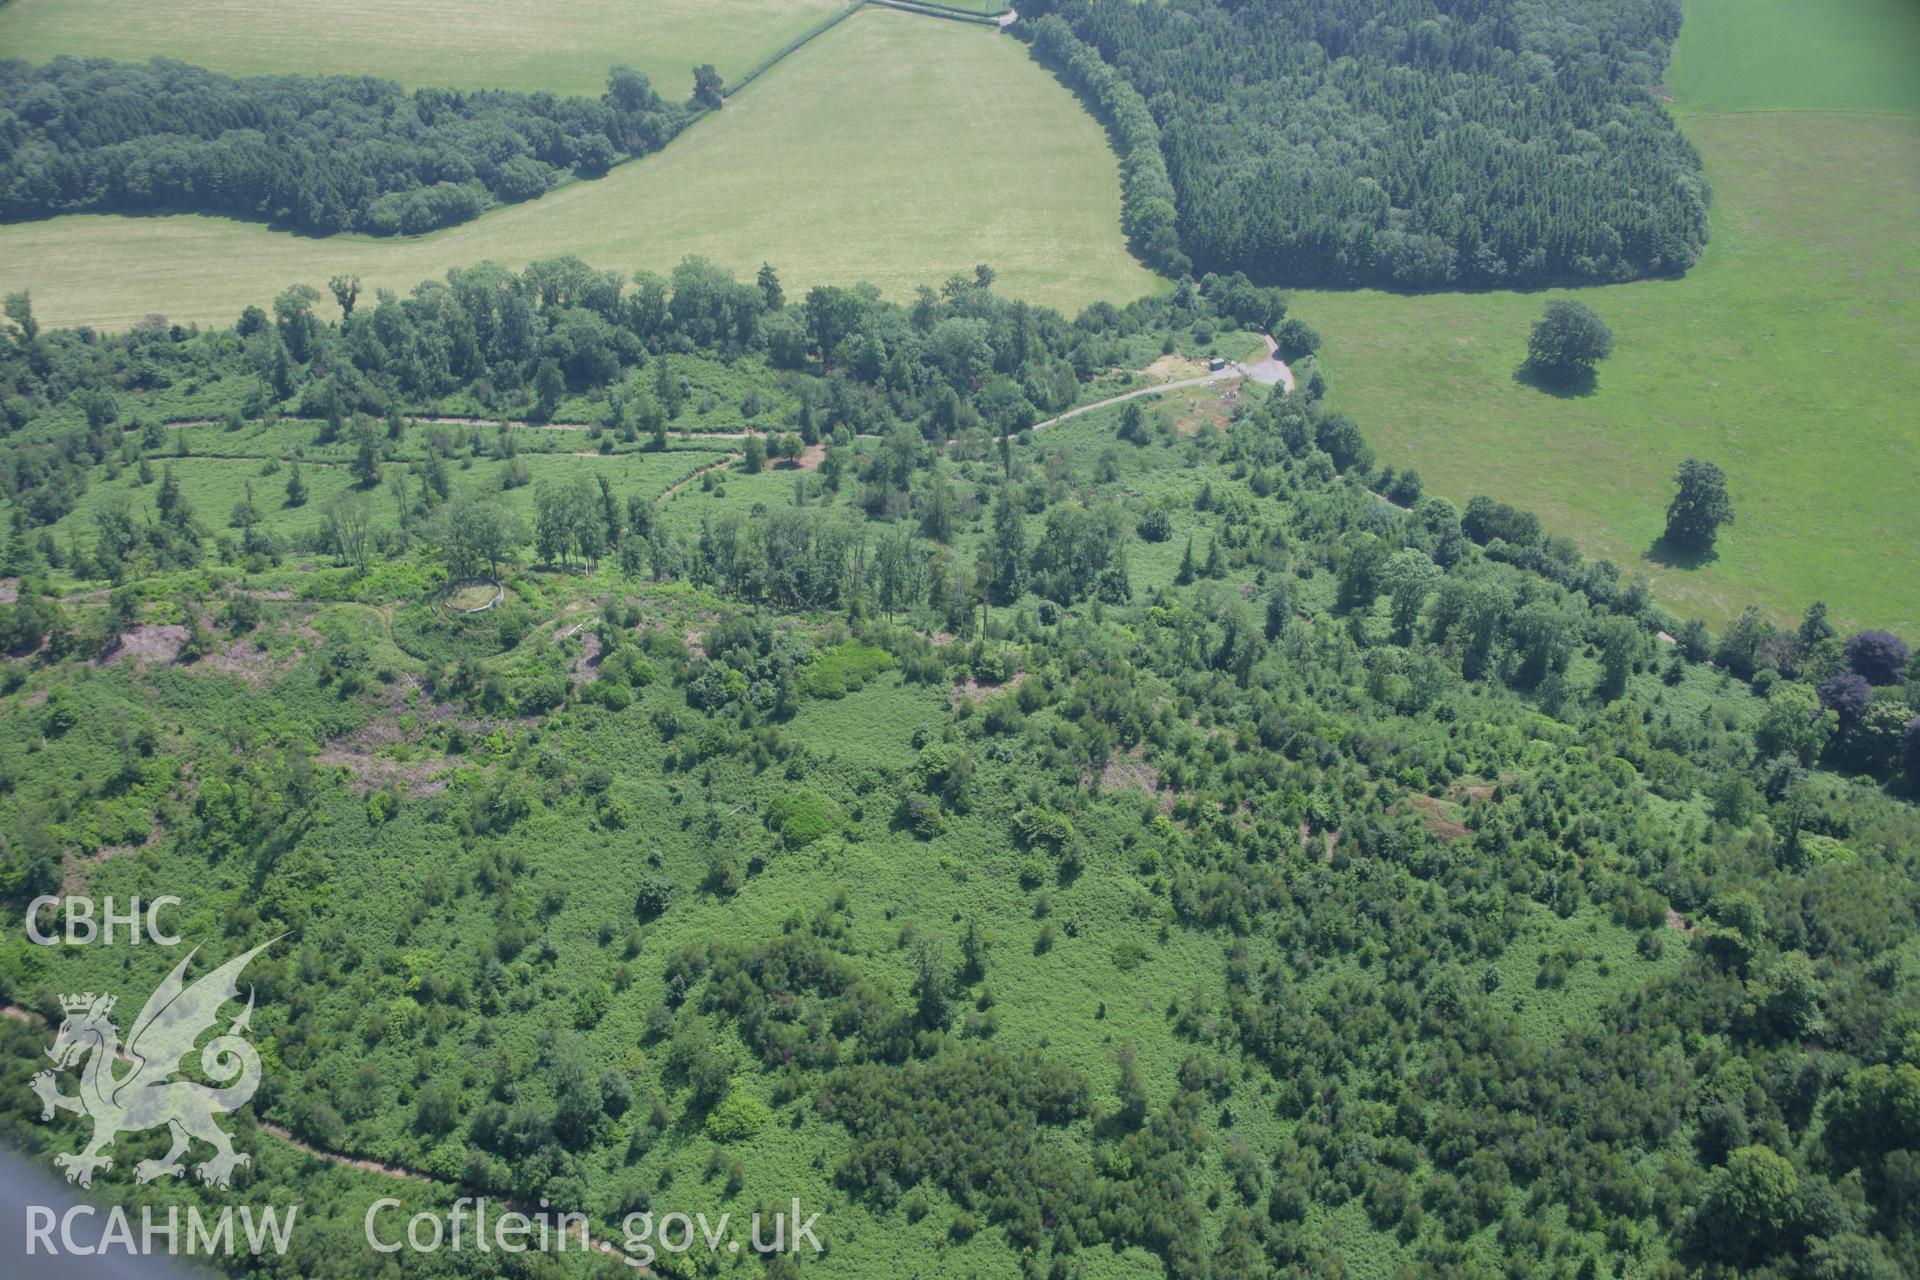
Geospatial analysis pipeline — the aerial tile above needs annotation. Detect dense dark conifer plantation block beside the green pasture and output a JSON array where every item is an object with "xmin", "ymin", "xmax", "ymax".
[{"xmin": 1021, "ymin": 0, "xmax": 1707, "ymax": 288}]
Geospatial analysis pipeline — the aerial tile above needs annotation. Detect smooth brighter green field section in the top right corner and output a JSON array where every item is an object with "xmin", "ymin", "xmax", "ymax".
[{"xmin": 1667, "ymin": 0, "xmax": 1920, "ymax": 111}]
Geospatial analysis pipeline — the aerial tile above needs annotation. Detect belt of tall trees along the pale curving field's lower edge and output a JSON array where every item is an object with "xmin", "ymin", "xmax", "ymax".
[{"xmin": 0, "ymin": 257, "xmax": 1284, "ymax": 537}]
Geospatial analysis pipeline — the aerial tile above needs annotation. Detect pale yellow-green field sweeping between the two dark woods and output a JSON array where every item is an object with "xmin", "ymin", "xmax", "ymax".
[{"xmin": 0, "ymin": 12, "xmax": 1158, "ymax": 328}]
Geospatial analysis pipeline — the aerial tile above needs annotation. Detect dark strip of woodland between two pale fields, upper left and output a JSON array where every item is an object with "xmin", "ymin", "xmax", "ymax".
[{"xmin": 0, "ymin": 58, "xmax": 697, "ymax": 236}]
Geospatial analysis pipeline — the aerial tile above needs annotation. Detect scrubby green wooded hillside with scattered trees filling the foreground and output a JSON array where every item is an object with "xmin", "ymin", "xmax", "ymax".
[{"xmin": 0, "ymin": 259, "xmax": 1920, "ymax": 1280}]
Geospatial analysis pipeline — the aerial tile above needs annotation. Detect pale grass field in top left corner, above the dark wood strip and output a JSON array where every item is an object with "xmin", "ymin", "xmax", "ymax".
[{"xmin": 0, "ymin": 0, "xmax": 845, "ymax": 98}]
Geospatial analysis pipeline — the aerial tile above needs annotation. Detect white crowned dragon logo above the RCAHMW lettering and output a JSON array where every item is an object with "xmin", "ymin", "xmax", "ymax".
[{"xmin": 33, "ymin": 942, "xmax": 273, "ymax": 1188}]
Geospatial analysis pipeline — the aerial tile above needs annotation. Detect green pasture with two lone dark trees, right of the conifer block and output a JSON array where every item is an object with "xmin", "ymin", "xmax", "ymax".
[{"xmin": 1296, "ymin": 0, "xmax": 1920, "ymax": 633}]
